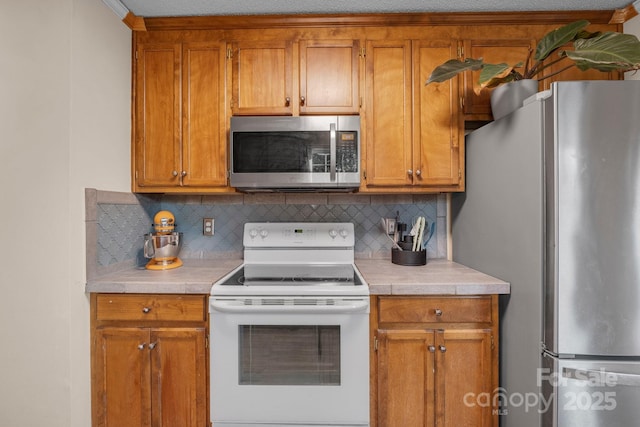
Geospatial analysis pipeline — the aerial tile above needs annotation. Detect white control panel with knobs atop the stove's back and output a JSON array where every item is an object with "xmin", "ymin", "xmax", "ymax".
[{"xmin": 243, "ymin": 222, "xmax": 355, "ymax": 248}]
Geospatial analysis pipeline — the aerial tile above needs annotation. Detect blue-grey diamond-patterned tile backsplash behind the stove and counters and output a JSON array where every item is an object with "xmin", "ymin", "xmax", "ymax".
[{"xmin": 87, "ymin": 189, "xmax": 447, "ymax": 278}]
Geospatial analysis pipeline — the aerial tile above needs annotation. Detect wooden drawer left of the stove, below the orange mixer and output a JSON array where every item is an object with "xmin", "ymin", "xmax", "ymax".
[{"xmin": 96, "ymin": 294, "xmax": 206, "ymax": 322}]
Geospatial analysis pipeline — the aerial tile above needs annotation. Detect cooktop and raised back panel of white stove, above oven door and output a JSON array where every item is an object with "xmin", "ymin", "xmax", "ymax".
[{"xmin": 211, "ymin": 223, "xmax": 369, "ymax": 296}]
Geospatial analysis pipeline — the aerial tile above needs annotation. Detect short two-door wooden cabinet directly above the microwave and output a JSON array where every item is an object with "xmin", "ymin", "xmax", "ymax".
[{"xmin": 229, "ymin": 40, "xmax": 360, "ymax": 115}]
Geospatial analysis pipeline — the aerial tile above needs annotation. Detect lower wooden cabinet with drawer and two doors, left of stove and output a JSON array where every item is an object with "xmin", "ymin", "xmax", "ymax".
[{"xmin": 91, "ymin": 294, "xmax": 209, "ymax": 427}]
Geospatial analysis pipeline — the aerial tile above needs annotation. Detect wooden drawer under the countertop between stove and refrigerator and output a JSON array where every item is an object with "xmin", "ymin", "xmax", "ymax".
[{"xmin": 380, "ymin": 296, "xmax": 491, "ymax": 323}]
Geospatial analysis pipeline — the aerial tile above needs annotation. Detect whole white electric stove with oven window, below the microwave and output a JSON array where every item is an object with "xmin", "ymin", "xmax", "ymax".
[{"xmin": 209, "ymin": 223, "xmax": 369, "ymax": 427}]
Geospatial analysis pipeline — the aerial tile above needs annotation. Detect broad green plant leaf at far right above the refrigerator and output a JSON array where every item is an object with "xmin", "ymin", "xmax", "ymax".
[{"xmin": 563, "ymin": 32, "xmax": 640, "ymax": 71}]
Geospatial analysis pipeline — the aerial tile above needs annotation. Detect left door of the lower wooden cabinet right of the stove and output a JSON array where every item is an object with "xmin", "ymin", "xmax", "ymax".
[{"xmin": 377, "ymin": 330, "xmax": 438, "ymax": 427}]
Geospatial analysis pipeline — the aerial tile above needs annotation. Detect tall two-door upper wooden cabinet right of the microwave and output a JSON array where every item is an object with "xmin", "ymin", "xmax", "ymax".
[{"xmin": 361, "ymin": 40, "xmax": 464, "ymax": 192}]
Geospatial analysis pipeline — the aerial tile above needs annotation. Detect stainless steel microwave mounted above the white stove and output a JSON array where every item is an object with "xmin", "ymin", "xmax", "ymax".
[{"xmin": 229, "ymin": 116, "xmax": 360, "ymax": 191}]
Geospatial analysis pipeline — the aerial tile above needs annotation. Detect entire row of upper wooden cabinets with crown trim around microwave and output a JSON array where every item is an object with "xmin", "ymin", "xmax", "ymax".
[{"xmin": 132, "ymin": 11, "xmax": 622, "ymax": 194}]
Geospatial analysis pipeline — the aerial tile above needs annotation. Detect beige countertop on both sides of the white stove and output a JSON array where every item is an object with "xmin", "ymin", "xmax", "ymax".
[{"xmin": 85, "ymin": 259, "xmax": 509, "ymax": 295}]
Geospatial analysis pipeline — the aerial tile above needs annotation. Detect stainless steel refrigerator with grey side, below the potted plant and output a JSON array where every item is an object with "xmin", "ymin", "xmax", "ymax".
[{"xmin": 451, "ymin": 81, "xmax": 640, "ymax": 427}]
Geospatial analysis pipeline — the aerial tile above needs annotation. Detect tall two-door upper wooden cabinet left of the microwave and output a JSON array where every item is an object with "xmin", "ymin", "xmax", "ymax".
[{"xmin": 132, "ymin": 42, "xmax": 227, "ymax": 192}]
